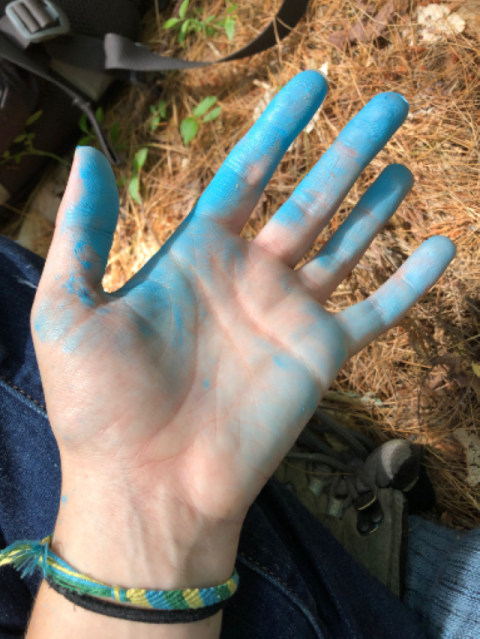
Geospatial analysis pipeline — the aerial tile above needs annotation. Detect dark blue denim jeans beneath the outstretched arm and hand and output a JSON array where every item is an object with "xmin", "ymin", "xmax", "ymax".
[{"xmin": 0, "ymin": 236, "xmax": 425, "ymax": 639}]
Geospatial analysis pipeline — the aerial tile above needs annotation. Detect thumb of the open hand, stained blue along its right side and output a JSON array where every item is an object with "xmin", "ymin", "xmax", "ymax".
[{"xmin": 39, "ymin": 146, "xmax": 119, "ymax": 306}]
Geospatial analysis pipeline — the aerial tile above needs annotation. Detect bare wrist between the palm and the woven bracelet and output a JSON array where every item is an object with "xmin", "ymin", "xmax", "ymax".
[{"xmin": 51, "ymin": 470, "xmax": 241, "ymax": 590}]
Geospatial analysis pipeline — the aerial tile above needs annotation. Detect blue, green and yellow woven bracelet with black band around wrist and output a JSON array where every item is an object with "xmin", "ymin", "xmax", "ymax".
[{"xmin": 0, "ymin": 535, "xmax": 239, "ymax": 623}]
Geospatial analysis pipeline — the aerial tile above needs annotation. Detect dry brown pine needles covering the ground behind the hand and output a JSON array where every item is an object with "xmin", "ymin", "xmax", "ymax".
[{"xmin": 7, "ymin": 0, "xmax": 480, "ymax": 528}]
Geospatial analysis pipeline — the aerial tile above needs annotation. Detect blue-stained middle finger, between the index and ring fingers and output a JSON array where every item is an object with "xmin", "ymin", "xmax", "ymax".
[{"xmin": 253, "ymin": 93, "xmax": 408, "ymax": 268}]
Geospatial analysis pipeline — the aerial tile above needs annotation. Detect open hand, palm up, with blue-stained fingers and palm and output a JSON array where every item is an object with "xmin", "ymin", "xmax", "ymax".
[{"xmin": 32, "ymin": 71, "xmax": 455, "ymax": 587}]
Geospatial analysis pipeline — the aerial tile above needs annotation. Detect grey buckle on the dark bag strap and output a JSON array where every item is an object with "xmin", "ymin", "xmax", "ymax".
[{"xmin": 5, "ymin": 0, "xmax": 70, "ymax": 42}]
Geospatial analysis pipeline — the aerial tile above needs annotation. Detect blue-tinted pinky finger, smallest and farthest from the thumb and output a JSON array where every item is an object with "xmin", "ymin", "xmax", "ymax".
[{"xmin": 336, "ymin": 235, "xmax": 455, "ymax": 357}]
